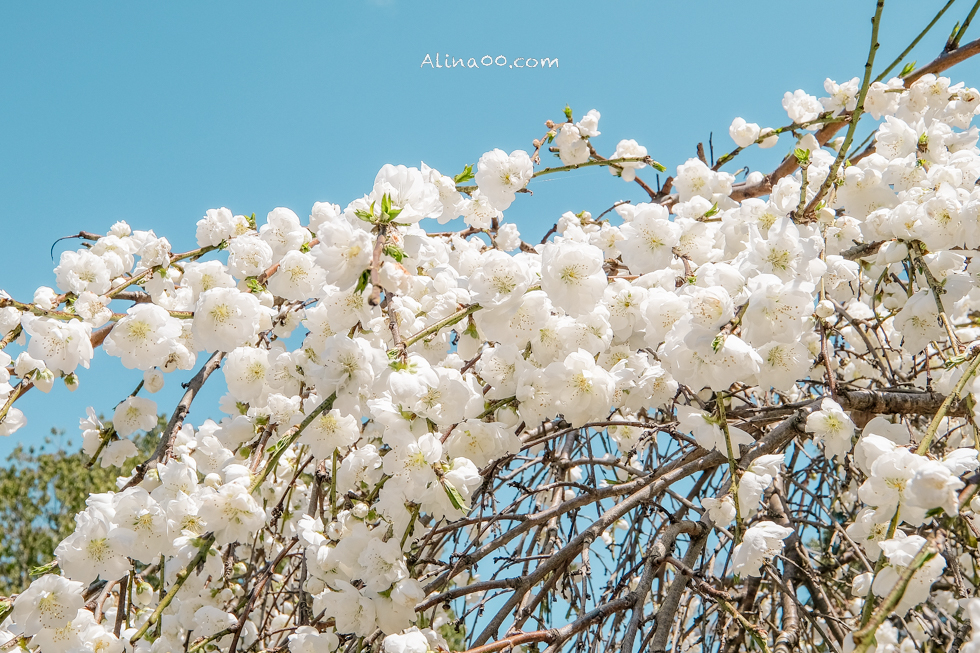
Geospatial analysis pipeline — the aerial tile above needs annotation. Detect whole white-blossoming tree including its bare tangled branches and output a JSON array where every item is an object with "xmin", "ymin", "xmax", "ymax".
[{"xmin": 11, "ymin": 5, "xmax": 980, "ymax": 653}]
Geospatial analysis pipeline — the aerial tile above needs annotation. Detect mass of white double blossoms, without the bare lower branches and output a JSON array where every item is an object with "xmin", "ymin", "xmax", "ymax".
[{"xmin": 0, "ymin": 70, "xmax": 980, "ymax": 653}]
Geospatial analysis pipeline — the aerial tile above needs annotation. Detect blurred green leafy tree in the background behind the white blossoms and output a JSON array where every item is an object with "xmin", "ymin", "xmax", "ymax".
[{"xmin": 0, "ymin": 415, "xmax": 160, "ymax": 596}]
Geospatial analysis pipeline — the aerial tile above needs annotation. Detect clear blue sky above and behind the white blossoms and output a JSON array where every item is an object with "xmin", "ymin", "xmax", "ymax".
[{"xmin": 0, "ymin": 0, "xmax": 980, "ymax": 455}]
